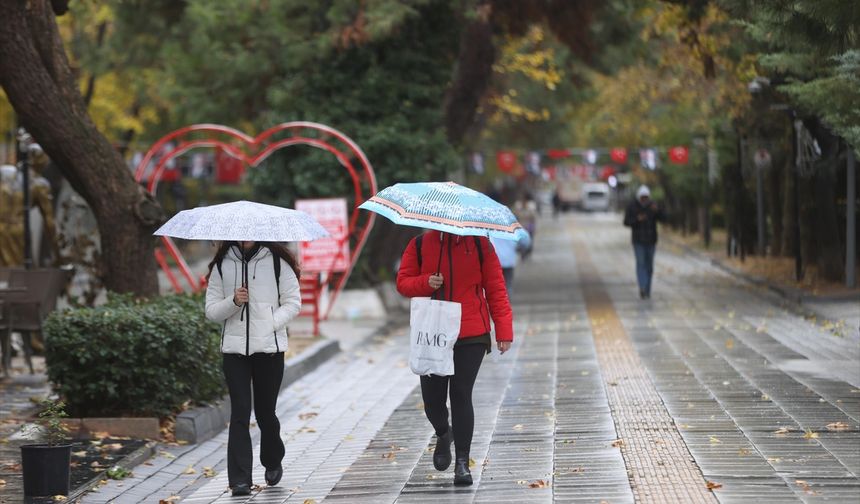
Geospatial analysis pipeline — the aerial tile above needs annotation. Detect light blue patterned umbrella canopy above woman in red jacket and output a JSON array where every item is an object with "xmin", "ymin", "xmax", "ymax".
[{"xmin": 359, "ymin": 182, "xmax": 528, "ymax": 240}]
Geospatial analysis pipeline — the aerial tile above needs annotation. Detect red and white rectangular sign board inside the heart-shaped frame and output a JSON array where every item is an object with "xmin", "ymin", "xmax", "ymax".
[{"xmin": 296, "ymin": 198, "xmax": 349, "ymax": 272}]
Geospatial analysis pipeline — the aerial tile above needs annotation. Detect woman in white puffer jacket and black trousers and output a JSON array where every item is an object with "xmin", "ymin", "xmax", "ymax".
[{"xmin": 206, "ymin": 241, "xmax": 301, "ymax": 495}]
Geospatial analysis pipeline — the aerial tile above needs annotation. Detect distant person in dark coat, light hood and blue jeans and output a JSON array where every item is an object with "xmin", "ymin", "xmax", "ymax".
[{"xmin": 624, "ymin": 185, "xmax": 666, "ymax": 299}]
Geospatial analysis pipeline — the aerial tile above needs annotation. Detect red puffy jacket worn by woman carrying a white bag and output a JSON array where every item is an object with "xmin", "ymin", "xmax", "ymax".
[{"xmin": 397, "ymin": 231, "xmax": 514, "ymax": 341}]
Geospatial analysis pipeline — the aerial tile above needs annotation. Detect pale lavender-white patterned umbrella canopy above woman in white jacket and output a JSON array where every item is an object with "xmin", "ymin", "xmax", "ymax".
[{"xmin": 153, "ymin": 201, "xmax": 329, "ymax": 242}]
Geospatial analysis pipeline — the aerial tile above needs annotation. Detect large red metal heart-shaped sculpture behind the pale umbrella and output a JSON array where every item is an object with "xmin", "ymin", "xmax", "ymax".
[{"xmin": 134, "ymin": 121, "xmax": 377, "ymax": 320}]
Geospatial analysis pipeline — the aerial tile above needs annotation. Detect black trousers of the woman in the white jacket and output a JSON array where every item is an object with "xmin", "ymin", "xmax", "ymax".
[{"xmin": 223, "ymin": 352, "xmax": 284, "ymax": 487}]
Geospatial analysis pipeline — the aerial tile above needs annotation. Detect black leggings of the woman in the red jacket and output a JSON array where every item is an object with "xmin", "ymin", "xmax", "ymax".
[{"xmin": 421, "ymin": 344, "xmax": 487, "ymax": 454}]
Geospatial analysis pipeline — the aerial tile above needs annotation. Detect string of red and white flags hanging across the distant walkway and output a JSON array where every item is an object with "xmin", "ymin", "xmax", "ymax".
[{"xmin": 471, "ymin": 145, "xmax": 690, "ymax": 175}]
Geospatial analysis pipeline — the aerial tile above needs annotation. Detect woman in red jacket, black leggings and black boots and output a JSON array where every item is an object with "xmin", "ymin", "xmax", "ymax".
[{"xmin": 397, "ymin": 231, "xmax": 514, "ymax": 485}]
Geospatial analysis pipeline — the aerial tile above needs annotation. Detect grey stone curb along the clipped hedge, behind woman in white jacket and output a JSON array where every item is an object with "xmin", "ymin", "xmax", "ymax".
[{"xmin": 176, "ymin": 340, "xmax": 340, "ymax": 444}]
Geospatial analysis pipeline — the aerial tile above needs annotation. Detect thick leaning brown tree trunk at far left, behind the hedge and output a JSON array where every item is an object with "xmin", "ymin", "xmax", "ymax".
[{"xmin": 0, "ymin": 0, "xmax": 163, "ymax": 296}]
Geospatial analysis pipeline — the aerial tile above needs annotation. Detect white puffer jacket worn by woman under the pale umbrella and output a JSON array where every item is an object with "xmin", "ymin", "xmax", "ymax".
[{"xmin": 206, "ymin": 246, "xmax": 302, "ymax": 355}]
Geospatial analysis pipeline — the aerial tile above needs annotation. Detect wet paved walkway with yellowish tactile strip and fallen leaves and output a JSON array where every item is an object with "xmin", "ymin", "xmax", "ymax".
[{"xmin": 83, "ymin": 214, "xmax": 860, "ymax": 504}]
